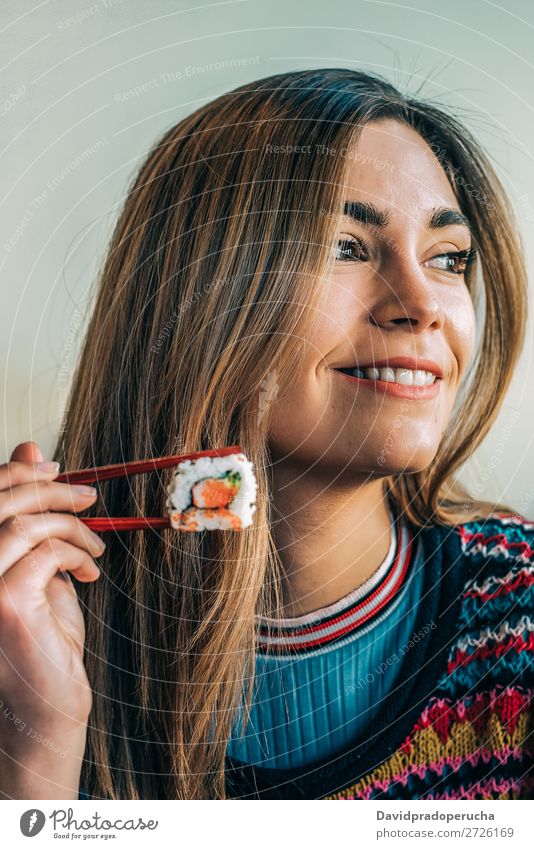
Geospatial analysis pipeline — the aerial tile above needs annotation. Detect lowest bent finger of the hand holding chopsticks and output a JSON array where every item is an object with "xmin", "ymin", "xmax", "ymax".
[{"xmin": 0, "ymin": 537, "xmax": 100, "ymax": 612}]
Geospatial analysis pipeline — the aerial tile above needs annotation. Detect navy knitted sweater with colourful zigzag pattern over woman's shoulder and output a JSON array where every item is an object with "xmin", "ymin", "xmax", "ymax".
[{"xmin": 226, "ymin": 514, "xmax": 534, "ymax": 800}]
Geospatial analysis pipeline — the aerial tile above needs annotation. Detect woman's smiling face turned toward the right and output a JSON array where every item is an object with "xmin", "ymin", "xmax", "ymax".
[{"xmin": 269, "ymin": 119, "xmax": 476, "ymax": 476}]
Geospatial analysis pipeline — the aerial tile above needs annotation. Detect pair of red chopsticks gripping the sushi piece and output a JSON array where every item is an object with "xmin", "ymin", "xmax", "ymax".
[{"xmin": 54, "ymin": 445, "xmax": 242, "ymax": 531}]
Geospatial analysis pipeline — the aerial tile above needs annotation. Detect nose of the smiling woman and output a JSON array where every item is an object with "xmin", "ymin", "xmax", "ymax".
[{"xmin": 370, "ymin": 256, "xmax": 444, "ymax": 333}]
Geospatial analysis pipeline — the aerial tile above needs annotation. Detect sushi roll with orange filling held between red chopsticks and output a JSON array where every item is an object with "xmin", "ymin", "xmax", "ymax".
[{"xmin": 166, "ymin": 453, "xmax": 256, "ymax": 531}]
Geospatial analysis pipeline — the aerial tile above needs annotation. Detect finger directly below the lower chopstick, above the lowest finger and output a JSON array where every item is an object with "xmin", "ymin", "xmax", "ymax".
[{"xmin": 0, "ymin": 513, "xmax": 105, "ymax": 575}]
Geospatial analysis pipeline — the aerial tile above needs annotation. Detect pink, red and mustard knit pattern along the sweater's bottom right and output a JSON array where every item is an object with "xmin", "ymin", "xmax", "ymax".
[{"xmin": 324, "ymin": 687, "xmax": 532, "ymax": 799}]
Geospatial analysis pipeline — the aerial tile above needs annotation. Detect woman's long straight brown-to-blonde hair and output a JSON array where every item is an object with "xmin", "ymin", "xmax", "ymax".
[{"xmin": 54, "ymin": 68, "xmax": 526, "ymax": 799}]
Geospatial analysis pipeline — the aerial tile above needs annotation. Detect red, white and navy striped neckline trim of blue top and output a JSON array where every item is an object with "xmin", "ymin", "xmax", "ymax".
[{"xmin": 256, "ymin": 521, "xmax": 413, "ymax": 655}]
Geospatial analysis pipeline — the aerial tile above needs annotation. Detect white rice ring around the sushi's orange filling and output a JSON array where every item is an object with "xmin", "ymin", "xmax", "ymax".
[{"xmin": 166, "ymin": 453, "xmax": 257, "ymax": 530}]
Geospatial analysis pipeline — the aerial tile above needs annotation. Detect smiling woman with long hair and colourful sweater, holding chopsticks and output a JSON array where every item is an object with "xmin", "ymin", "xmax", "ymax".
[{"xmin": 0, "ymin": 68, "xmax": 534, "ymax": 799}]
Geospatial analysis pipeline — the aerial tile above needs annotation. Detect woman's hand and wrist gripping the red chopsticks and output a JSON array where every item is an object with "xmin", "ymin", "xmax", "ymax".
[{"xmin": 0, "ymin": 442, "xmax": 105, "ymax": 799}]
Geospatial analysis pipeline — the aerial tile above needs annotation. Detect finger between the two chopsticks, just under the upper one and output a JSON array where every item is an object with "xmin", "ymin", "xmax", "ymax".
[{"xmin": 0, "ymin": 480, "xmax": 97, "ymax": 524}]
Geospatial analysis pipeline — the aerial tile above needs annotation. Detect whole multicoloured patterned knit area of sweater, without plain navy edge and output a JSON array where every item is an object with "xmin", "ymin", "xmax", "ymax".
[{"xmin": 326, "ymin": 518, "xmax": 534, "ymax": 799}]
